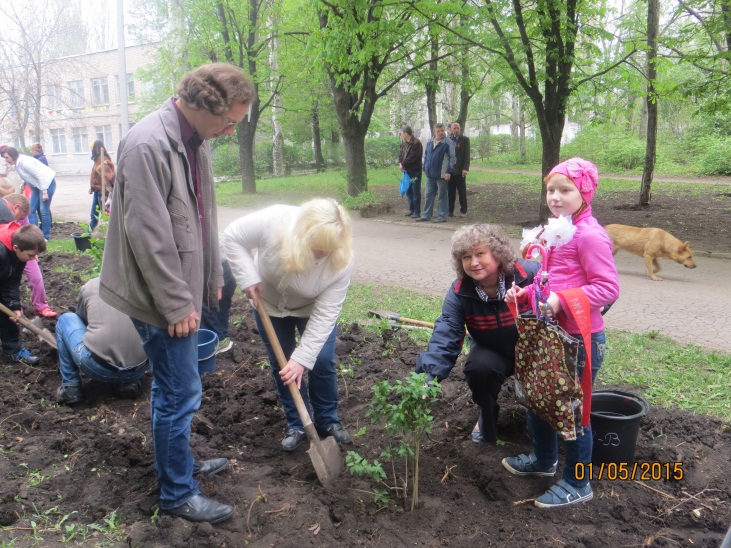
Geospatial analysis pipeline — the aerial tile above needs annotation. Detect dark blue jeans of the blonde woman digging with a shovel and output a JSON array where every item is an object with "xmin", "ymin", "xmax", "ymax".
[{"xmin": 254, "ymin": 310, "xmax": 340, "ymax": 432}]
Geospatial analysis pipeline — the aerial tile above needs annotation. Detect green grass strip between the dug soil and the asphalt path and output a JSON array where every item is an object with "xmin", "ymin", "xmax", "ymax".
[{"xmin": 340, "ymin": 284, "xmax": 731, "ymax": 422}]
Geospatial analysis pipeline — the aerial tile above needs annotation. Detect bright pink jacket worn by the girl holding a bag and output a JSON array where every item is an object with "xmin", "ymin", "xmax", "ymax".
[{"xmin": 526, "ymin": 206, "xmax": 619, "ymax": 334}]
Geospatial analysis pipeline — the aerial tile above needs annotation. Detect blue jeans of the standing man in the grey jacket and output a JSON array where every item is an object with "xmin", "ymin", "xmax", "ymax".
[{"xmin": 132, "ymin": 318, "xmax": 202, "ymax": 510}]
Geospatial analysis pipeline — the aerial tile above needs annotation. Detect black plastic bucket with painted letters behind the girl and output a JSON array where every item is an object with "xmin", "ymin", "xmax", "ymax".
[{"xmin": 591, "ymin": 390, "xmax": 650, "ymax": 464}]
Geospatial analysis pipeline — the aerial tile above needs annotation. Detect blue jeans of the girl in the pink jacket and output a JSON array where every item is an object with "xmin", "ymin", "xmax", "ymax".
[{"xmin": 527, "ymin": 331, "xmax": 607, "ymax": 487}]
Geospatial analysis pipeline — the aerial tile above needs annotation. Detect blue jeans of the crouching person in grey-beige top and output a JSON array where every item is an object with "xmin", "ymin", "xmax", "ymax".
[{"xmin": 56, "ymin": 312, "xmax": 149, "ymax": 386}]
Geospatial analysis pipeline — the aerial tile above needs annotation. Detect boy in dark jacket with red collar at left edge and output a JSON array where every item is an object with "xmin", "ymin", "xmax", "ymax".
[{"xmin": 0, "ymin": 222, "xmax": 46, "ymax": 365}]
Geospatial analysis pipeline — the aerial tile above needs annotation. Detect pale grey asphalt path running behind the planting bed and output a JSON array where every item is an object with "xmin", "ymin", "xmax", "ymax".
[{"xmin": 52, "ymin": 176, "xmax": 731, "ymax": 352}]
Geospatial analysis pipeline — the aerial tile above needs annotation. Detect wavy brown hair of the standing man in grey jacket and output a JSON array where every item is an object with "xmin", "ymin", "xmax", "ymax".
[{"xmin": 177, "ymin": 63, "xmax": 256, "ymax": 116}]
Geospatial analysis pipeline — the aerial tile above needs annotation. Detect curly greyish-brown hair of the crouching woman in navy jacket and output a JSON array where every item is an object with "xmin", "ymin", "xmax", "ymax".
[{"xmin": 452, "ymin": 224, "xmax": 517, "ymax": 280}]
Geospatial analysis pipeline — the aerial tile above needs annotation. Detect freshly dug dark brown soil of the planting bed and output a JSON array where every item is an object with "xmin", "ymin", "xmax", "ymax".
[{"xmin": 0, "ymin": 223, "xmax": 731, "ymax": 548}]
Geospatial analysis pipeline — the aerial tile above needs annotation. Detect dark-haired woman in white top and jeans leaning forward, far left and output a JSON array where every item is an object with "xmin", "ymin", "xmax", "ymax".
[{"xmin": 3, "ymin": 147, "xmax": 56, "ymax": 240}]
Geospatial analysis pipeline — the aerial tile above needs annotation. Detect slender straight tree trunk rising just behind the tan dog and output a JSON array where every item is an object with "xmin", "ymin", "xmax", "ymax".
[{"xmin": 640, "ymin": 0, "xmax": 660, "ymax": 206}]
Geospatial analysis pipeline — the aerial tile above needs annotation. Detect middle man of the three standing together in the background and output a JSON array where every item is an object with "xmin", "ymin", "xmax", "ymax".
[{"xmin": 416, "ymin": 123, "xmax": 456, "ymax": 223}]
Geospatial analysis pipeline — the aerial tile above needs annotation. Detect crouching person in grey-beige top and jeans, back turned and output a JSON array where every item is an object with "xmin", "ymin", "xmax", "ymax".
[{"xmin": 56, "ymin": 278, "xmax": 150, "ymax": 405}]
